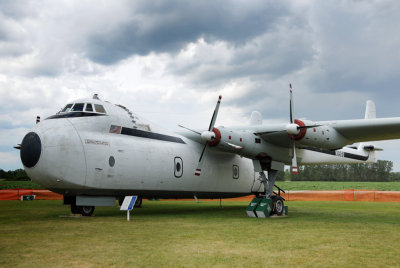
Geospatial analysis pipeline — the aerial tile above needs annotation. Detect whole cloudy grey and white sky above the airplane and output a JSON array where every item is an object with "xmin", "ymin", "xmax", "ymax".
[{"xmin": 0, "ymin": 0, "xmax": 400, "ymax": 171}]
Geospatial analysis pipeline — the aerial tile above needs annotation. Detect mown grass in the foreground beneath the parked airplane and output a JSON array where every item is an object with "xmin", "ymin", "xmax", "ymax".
[{"xmin": 0, "ymin": 201, "xmax": 400, "ymax": 267}]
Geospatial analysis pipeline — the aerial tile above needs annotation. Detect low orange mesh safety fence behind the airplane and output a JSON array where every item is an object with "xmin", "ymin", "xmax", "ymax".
[{"xmin": 0, "ymin": 189, "xmax": 400, "ymax": 202}]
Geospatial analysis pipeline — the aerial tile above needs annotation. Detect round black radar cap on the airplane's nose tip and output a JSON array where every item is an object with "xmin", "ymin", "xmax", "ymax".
[{"xmin": 20, "ymin": 132, "xmax": 42, "ymax": 168}]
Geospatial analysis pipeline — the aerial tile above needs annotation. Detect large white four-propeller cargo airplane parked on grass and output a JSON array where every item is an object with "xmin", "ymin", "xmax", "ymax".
[{"xmin": 16, "ymin": 89, "xmax": 400, "ymax": 216}]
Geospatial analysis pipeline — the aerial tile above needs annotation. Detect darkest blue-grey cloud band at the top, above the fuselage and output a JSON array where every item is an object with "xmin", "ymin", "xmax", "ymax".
[{"xmin": 86, "ymin": 1, "xmax": 288, "ymax": 64}]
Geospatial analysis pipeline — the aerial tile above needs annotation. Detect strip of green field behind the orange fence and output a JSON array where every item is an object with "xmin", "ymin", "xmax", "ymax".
[{"xmin": 0, "ymin": 181, "xmax": 400, "ymax": 191}]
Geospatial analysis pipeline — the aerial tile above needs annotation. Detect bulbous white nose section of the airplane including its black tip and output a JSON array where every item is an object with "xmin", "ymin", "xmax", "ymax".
[{"xmin": 20, "ymin": 118, "xmax": 86, "ymax": 193}]
